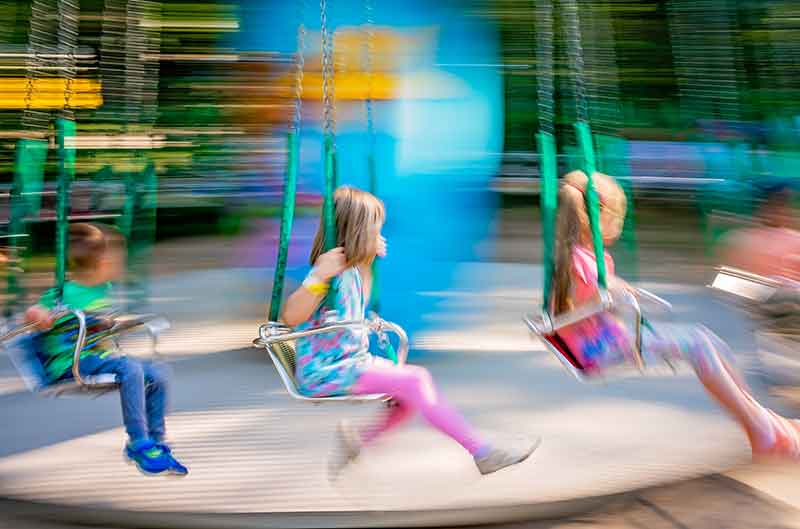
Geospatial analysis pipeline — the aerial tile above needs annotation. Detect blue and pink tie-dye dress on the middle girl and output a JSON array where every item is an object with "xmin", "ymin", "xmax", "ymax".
[{"xmin": 295, "ymin": 267, "xmax": 372, "ymax": 397}]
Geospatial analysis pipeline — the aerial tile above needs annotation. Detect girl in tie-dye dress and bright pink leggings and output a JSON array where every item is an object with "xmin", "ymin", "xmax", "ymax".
[{"xmin": 282, "ymin": 187, "xmax": 536, "ymax": 478}]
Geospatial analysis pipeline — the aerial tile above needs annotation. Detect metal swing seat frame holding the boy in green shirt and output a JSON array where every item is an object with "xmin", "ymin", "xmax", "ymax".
[{"xmin": 0, "ymin": 307, "xmax": 169, "ymax": 397}]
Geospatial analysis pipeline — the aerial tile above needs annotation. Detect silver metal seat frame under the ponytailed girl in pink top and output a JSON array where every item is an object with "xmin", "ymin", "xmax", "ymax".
[{"xmin": 522, "ymin": 289, "xmax": 672, "ymax": 382}]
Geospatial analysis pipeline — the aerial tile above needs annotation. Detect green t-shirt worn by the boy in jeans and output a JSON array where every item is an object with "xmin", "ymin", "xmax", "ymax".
[{"xmin": 39, "ymin": 281, "xmax": 112, "ymax": 380}]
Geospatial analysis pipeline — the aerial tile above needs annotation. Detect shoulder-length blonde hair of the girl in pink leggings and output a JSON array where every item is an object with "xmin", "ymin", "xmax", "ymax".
[{"xmin": 309, "ymin": 186, "xmax": 386, "ymax": 266}]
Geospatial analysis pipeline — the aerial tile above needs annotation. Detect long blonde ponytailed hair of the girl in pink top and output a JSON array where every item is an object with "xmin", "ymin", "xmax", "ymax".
[{"xmin": 551, "ymin": 171, "xmax": 626, "ymax": 315}]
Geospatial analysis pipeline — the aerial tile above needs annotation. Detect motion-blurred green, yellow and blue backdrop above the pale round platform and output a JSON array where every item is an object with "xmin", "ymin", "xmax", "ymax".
[{"xmin": 0, "ymin": 0, "xmax": 800, "ymax": 318}]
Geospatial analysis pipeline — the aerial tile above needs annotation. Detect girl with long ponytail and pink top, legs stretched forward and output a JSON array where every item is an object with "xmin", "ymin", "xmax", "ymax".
[{"xmin": 551, "ymin": 171, "xmax": 800, "ymax": 459}]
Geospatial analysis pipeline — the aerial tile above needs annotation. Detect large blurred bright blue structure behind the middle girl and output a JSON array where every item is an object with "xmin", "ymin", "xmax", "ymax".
[{"xmin": 239, "ymin": 0, "xmax": 504, "ymax": 338}]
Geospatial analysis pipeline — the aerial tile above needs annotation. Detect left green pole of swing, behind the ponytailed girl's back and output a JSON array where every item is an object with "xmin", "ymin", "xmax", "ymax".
[{"xmin": 536, "ymin": 132, "xmax": 558, "ymax": 314}]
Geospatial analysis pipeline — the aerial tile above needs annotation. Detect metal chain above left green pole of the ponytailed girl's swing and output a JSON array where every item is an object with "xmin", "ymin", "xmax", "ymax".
[{"xmin": 535, "ymin": 0, "xmax": 555, "ymax": 135}]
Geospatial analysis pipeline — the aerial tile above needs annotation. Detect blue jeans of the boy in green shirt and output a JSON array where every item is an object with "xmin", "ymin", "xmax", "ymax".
[{"xmin": 74, "ymin": 355, "xmax": 170, "ymax": 442}]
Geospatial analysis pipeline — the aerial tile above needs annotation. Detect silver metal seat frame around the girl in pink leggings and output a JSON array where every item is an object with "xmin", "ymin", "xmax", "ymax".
[{"xmin": 253, "ymin": 317, "xmax": 408, "ymax": 404}]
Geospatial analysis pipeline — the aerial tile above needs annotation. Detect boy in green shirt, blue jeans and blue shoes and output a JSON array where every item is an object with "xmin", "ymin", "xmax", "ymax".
[{"xmin": 25, "ymin": 223, "xmax": 188, "ymax": 475}]
